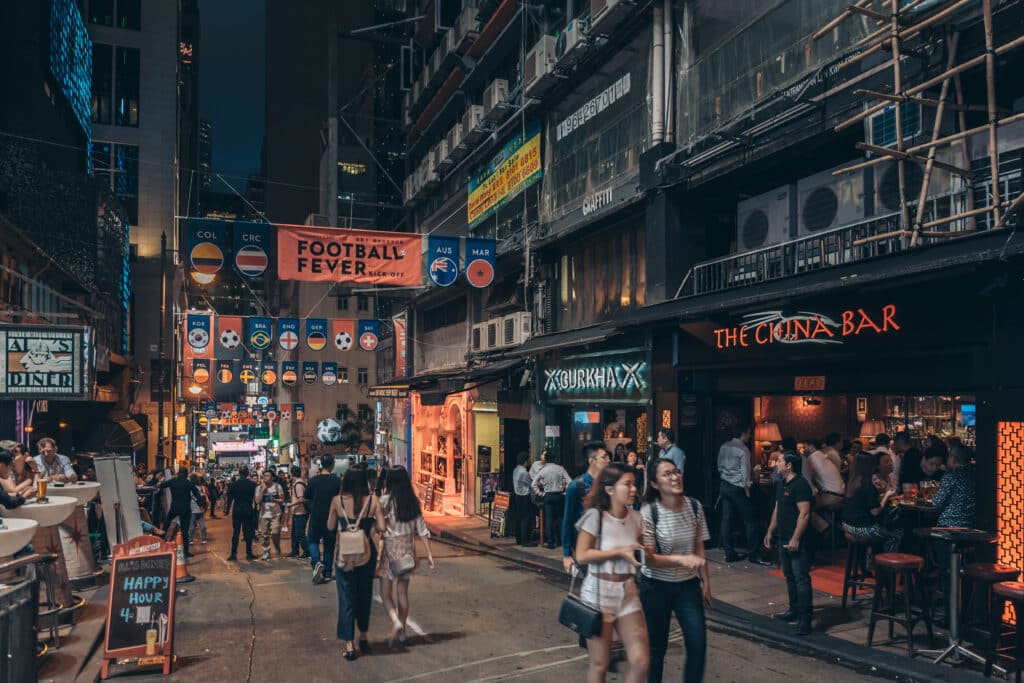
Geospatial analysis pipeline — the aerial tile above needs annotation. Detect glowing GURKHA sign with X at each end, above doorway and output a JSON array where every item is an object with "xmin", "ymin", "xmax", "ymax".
[{"xmin": 544, "ymin": 349, "xmax": 650, "ymax": 402}]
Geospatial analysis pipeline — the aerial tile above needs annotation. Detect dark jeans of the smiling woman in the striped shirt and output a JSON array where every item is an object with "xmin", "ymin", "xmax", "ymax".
[{"xmin": 640, "ymin": 577, "xmax": 708, "ymax": 683}]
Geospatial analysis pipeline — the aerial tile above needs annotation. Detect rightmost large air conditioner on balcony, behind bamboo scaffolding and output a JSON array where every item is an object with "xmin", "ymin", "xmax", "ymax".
[{"xmin": 874, "ymin": 140, "xmax": 970, "ymax": 215}]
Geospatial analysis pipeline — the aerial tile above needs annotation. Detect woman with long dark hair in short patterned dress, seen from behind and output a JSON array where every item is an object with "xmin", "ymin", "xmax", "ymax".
[{"xmin": 377, "ymin": 467, "xmax": 434, "ymax": 645}]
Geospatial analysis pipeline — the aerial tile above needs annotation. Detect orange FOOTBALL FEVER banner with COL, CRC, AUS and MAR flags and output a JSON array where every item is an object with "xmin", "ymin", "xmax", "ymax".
[{"xmin": 191, "ymin": 218, "xmax": 498, "ymax": 289}]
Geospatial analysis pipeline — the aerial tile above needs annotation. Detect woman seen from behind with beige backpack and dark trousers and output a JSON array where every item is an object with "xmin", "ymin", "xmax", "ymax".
[{"xmin": 327, "ymin": 466, "xmax": 380, "ymax": 661}]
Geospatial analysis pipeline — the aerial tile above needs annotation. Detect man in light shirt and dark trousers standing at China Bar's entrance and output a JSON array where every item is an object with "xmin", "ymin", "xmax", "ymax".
[{"xmin": 718, "ymin": 427, "xmax": 770, "ymax": 565}]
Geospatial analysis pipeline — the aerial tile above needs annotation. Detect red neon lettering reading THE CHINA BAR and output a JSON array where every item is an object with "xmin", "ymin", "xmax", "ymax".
[{"xmin": 715, "ymin": 304, "xmax": 900, "ymax": 349}]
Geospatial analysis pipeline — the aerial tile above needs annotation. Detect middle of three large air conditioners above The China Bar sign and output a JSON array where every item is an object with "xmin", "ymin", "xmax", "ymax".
[{"xmin": 797, "ymin": 164, "xmax": 864, "ymax": 237}]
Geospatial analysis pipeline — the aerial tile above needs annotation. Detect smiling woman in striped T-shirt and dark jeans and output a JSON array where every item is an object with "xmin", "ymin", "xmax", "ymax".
[{"xmin": 640, "ymin": 459, "xmax": 711, "ymax": 683}]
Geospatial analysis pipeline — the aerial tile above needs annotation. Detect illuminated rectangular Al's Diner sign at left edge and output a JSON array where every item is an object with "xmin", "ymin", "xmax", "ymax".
[{"xmin": 0, "ymin": 326, "xmax": 89, "ymax": 398}]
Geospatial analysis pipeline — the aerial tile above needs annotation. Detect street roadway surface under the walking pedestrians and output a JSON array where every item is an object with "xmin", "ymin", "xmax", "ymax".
[{"xmin": 86, "ymin": 520, "xmax": 888, "ymax": 683}]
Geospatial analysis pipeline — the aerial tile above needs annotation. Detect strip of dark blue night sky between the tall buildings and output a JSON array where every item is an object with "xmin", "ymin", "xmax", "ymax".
[{"xmin": 200, "ymin": 0, "xmax": 266, "ymax": 191}]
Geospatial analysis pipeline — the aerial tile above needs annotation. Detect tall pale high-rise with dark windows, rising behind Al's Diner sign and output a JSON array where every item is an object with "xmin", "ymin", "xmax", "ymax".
[{"xmin": 82, "ymin": 0, "xmax": 181, "ymax": 464}]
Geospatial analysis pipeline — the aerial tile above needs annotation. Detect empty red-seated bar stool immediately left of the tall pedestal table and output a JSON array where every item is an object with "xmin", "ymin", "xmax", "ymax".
[{"xmin": 867, "ymin": 553, "xmax": 934, "ymax": 656}]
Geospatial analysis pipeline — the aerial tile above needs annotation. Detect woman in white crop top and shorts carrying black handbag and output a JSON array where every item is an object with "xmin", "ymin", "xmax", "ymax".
[{"xmin": 575, "ymin": 463, "xmax": 649, "ymax": 683}]
